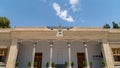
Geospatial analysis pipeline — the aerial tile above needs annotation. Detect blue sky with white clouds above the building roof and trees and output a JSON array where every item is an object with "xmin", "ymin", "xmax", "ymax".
[{"xmin": 0, "ymin": 0, "xmax": 120, "ymax": 27}]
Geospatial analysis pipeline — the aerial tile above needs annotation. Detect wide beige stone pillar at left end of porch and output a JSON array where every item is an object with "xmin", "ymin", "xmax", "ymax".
[{"xmin": 6, "ymin": 38, "xmax": 18, "ymax": 68}]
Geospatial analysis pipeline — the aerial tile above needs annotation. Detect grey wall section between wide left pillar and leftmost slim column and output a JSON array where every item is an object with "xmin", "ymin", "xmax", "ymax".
[{"xmin": 17, "ymin": 43, "xmax": 33, "ymax": 68}]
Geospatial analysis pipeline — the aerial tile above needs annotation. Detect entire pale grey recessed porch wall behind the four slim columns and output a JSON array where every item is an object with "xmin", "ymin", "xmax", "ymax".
[{"xmin": 18, "ymin": 40, "xmax": 102, "ymax": 68}]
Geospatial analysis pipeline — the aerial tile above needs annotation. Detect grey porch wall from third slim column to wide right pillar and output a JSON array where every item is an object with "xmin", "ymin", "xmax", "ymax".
[{"xmin": 71, "ymin": 42, "xmax": 102, "ymax": 68}]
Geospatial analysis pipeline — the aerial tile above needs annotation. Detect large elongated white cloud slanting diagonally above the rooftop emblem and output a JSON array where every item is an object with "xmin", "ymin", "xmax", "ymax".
[{"xmin": 53, "ymin": 3, "xmax": 74, "ymax": 22}]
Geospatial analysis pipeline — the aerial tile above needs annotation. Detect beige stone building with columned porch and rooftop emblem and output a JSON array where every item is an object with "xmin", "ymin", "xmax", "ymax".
[{"xmin": 0, "ymin": 26, "xmax": 120, "ymax": 68}]
